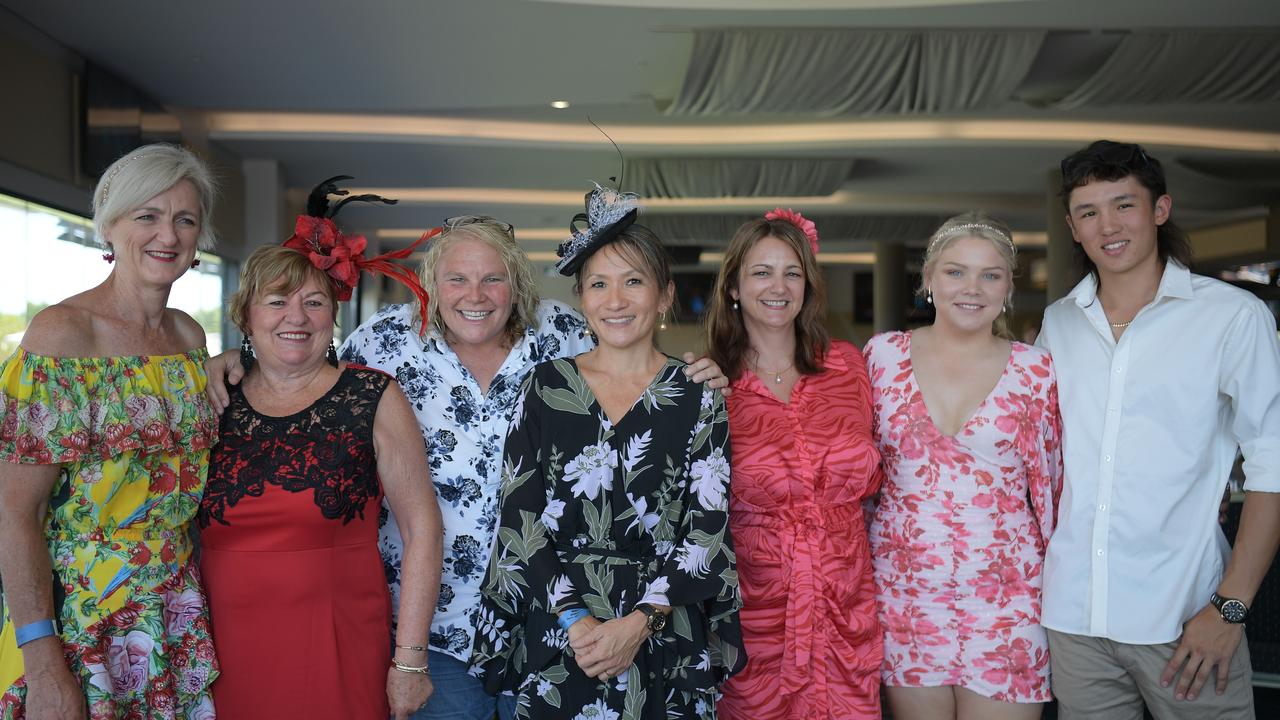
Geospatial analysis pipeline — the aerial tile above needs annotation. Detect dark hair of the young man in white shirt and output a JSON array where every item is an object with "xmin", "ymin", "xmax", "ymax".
[{"xmin": 1062, "ymin": 140, "xmax": 1192, "ymax": 283}]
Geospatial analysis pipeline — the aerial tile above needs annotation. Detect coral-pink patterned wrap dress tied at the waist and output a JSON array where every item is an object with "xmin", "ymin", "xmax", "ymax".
[{"xmin": 719, "ymin": 341, "xmax": 883, "ymax": 720}]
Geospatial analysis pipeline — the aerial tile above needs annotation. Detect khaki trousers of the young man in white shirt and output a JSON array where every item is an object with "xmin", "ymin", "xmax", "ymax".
[{"xmin": 1048, "ymin": 630, "xmax": 1254, "ymax": 720}]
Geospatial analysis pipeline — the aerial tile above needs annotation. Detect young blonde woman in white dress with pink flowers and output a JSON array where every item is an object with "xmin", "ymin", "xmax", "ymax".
[{"xmin": 865, "ymin": 213, "xmax": 1062, "ymax": 720}]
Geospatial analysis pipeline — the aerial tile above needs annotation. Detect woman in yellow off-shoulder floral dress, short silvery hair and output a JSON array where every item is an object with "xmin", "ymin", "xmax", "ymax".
[{"xmin": 0, "ymin": 145, "xmax": 218, "ymax": 720}]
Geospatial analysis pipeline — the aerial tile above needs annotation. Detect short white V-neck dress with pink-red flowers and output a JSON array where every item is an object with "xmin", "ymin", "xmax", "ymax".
[{"xmin": 867, "ymin": 332, "xmax": 1062, "ymax": 702}]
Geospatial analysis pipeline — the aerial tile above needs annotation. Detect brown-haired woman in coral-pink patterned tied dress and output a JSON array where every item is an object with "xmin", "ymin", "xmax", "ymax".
[{"xmin": 708, "ymin": 210, "xmax": 882, "ymax": 720}]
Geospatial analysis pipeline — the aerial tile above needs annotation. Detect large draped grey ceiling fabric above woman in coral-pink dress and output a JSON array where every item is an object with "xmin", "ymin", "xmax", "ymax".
[{"xmin": 667, "ymin": 29, "xmax": 1044, "ymax": 117}]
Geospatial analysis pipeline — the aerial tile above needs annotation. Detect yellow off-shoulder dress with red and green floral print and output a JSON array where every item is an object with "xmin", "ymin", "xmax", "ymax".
[{"xmin": 0, "ymin": 348, "xmax": 218, "ymax": 720}]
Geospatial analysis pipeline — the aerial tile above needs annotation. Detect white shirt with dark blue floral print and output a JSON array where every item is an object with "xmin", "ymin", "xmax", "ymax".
[{"xmin": 342, "ymin": 300, "xmax": 595, "ymax": 661}]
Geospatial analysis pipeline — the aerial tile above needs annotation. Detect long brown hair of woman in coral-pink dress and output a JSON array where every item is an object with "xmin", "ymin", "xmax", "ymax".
[{"xmin": 707, "ymin": 218, "xmax": 831, "ymax": 379}]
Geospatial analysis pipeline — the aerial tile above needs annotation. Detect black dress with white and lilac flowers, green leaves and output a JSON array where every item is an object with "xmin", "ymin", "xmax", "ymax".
[{"xmin": 472, "ymin": 360, "xmax": 746, "ymax": 720}]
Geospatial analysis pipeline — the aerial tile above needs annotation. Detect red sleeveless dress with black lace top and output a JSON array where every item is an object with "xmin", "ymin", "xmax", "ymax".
[{"xmin": 198, "ymin": 365, "xmax": 390, "ymax": 720}]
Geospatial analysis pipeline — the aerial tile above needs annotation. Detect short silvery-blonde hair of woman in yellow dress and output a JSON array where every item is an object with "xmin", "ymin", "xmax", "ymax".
[{"xmin": 93, "ymin": 142, "xmax": 218, "ymax": 250}]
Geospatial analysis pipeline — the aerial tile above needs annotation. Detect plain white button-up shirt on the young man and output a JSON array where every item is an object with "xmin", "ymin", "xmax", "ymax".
[{"xmin": 1038, "ymin": 261, "xmax": 1280, "ymax": 644}]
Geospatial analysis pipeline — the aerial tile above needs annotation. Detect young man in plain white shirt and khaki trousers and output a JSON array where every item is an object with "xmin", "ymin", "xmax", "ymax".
[{"xmin": 1038, "ymin": 141, "xmax": 1280, "ymax": 720}]
